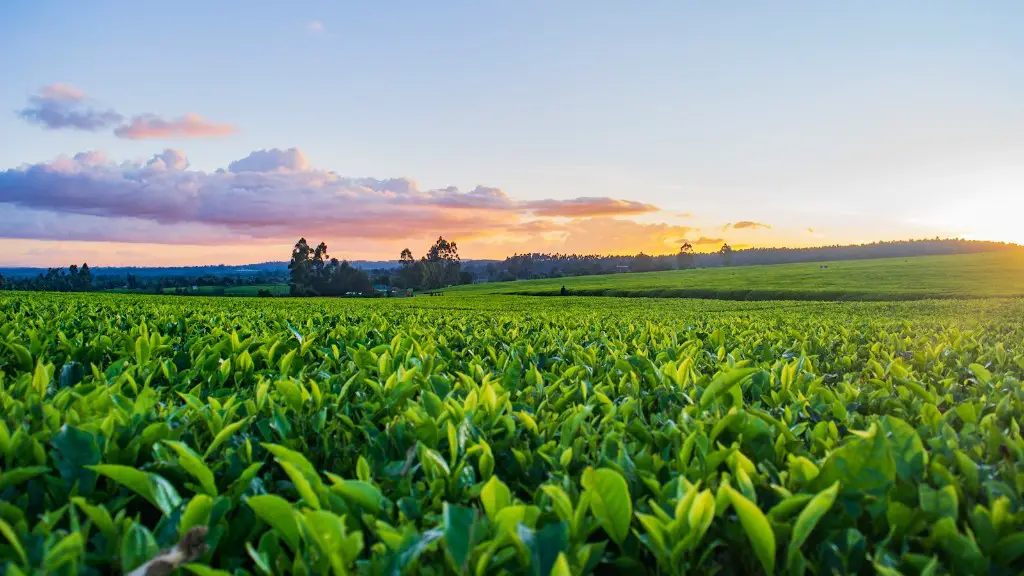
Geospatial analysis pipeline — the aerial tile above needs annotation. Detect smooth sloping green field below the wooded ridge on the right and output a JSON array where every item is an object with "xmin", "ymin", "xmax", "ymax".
[{"xmin": 446, "ymin": 252, "xmax": 1024, "ymax": 300}]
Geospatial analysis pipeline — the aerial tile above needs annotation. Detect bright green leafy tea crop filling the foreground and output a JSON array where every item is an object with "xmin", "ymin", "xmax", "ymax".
[{"xmin": 0, "ymin": 289, "xmax": 1024, "ymax": 576}]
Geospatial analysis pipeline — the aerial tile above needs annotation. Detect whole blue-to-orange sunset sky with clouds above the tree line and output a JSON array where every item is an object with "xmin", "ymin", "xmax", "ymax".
[{"xmin": 0, "ymin": 0, "xmax": 1024, "ymax": 266}]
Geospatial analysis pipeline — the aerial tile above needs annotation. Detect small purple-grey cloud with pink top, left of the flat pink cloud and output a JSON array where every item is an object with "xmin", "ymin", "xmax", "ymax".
[{"xmin": 17, "ymin": 84, "xmax": 124, "ymax": 132}]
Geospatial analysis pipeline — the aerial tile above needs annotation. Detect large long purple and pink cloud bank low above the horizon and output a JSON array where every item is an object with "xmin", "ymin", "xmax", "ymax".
[{"xmin": 0, "ymin": 148, "xmax": 663, "ymax": 247}]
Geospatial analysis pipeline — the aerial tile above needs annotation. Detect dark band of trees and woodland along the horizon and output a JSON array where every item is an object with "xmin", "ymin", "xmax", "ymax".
[{"xmin": 6, "ymin": 237, "xmax": 1022, "ymax": 295}]
